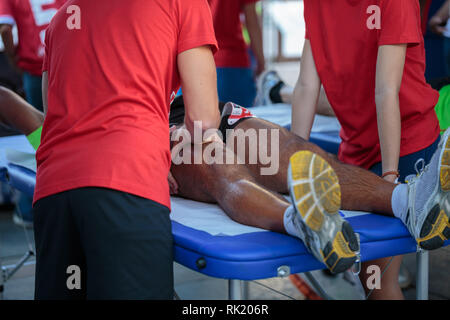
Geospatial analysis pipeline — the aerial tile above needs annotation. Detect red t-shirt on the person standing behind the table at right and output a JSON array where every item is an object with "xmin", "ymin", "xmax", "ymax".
[{"xmin": 304, "ymin": 0, "xmax": 439, "ymax": 168}]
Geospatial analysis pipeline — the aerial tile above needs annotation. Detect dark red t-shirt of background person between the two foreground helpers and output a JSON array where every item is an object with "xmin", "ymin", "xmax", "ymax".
[{"xmin": 208, "ymin": 0, "xmax": 259, "ymax": 68}]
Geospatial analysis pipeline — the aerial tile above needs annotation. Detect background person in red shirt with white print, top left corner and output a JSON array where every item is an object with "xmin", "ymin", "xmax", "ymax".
[{"xmin": 0, "ymin": 0, "xmax": 66, "ymax": 111}]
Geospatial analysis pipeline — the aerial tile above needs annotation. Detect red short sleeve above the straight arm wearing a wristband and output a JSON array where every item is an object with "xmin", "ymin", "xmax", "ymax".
[{"xmin": 378, "ymin": 0, "xmax": 422, "ymax": 46}]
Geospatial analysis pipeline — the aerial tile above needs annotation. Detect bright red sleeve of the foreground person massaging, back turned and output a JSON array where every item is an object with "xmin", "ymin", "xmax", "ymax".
[{"xmin": 178, "ymin": 0, "xmax": 218, "ymax": 54}]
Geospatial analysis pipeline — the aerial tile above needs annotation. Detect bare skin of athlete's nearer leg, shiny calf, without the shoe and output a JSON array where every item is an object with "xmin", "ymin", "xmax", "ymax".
[{"xmin": 171, "ymin": 141, "xmax": 290, "ymax": 233}]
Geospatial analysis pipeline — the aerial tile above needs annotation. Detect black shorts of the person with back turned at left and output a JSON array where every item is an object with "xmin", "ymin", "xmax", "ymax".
[{"xmin": 34, "ymin": 188, "xmax": 173, "ymax": 300}]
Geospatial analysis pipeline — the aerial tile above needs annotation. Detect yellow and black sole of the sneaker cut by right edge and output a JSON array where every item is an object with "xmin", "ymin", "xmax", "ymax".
[{"xmin": 417, "ymin": 132, "xmax": 450, "ymax": 250}]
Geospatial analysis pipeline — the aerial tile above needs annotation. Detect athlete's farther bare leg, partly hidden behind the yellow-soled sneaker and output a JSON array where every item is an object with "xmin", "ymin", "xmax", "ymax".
[{"xmin": 227, "ymin": 118, "xmax": 396, "ymax": 216}]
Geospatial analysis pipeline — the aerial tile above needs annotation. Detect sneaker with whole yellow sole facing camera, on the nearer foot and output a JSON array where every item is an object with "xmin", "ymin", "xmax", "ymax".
[{"xmin": 288, "ymin": 151, "xmax": 359, "ymax": 273}]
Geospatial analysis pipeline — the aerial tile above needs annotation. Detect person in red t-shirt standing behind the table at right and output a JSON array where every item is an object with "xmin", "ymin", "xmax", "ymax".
[{"xmin": 292, "ymin": 0, "xmax": 440, "ymax": 299}]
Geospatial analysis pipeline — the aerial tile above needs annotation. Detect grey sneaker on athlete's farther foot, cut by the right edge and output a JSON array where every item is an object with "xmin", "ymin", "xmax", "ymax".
[{"xmin": 403, "ymin": 129, "xmax": 450, "ymax": 250}]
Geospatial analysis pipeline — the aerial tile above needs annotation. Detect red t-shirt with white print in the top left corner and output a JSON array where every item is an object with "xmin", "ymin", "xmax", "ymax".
[{"xmin": 0, "ymin": 0, "xmax": 66, "ymax": 75}]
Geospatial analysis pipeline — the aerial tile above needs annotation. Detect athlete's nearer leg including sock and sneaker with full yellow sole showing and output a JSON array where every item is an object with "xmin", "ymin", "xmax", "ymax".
[{"xmin": 171, "ymin": 143, "xmax": 358, "ymax": 273}]
